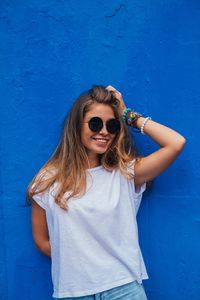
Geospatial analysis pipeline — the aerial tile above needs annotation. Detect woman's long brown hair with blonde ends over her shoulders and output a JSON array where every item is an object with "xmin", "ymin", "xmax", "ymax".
[{"xmin": 27, "ymin": 85, "xmax": 136, "ymax": 209}]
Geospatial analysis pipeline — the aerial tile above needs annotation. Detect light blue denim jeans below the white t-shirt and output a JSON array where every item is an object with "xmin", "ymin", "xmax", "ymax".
[{"xmin": 54, "ymin": 281, "xmax": 147, "ymax": 300}]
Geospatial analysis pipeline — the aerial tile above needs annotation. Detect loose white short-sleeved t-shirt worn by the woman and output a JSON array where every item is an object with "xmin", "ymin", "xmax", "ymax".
[{"xmin": 33, "ymin": 166, "xmax": 148, "ymax": 298}]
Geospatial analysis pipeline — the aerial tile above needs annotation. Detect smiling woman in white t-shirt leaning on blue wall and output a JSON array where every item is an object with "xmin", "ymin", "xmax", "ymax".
[{"xmin": 28, "ymin": 86, "xmax": 185, "ymax": 300}]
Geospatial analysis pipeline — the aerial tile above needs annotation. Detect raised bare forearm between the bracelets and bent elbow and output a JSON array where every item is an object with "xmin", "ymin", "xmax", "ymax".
[{"xmin": 136, "ymin": 117, "xmax": 185, "ymax": 151}]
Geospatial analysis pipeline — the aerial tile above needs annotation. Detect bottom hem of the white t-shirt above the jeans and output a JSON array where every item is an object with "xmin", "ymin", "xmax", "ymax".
[{"xmin": 52, "ymin": 276, "xmax": 149, "ymax": 298}]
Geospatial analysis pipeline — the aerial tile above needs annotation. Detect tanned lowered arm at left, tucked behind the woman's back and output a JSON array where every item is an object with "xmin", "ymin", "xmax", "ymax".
[{"xmin": 32, "ymin": 201, "xmax": 51, "ymax": 257}]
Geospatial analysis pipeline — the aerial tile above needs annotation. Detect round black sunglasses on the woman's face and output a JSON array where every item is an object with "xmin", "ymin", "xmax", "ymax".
[{"xmin": 87, "ymin": 117, "xmax": 121, "ymax": 134}]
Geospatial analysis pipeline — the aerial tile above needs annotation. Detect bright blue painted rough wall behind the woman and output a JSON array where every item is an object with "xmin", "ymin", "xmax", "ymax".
[{"xmin": 0, "ymin": 0, "xmax": 200, "ymax": 300}]
